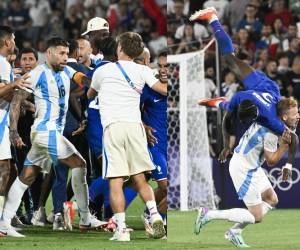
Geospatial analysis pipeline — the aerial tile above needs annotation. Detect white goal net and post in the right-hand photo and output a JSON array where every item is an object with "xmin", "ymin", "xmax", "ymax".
[{"xmin": 167, "ymin": 47, "xmax": 215, "ymax": 211}]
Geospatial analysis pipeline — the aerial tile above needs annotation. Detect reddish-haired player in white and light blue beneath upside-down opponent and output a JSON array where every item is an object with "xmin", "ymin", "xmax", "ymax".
[{"xmin": 195, "ymin": 98, "xmax": 300, "ymax": 247}]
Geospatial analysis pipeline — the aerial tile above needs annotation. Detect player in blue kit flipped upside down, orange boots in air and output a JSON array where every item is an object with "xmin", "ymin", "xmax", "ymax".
[{"xmin": 190, "ymin": 8, "xmax": 299, "ymax": 175}]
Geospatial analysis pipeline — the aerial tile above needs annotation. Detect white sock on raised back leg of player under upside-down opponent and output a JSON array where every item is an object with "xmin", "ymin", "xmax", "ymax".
[{"xmin": 206, "ymin": 208, "xmax": 255, "ymax": 224}]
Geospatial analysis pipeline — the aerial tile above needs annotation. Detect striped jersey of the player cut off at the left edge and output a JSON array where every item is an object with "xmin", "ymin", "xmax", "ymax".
[{"xmin": 0, "ymin": 55, "xmax": 13, "ymax": 143}]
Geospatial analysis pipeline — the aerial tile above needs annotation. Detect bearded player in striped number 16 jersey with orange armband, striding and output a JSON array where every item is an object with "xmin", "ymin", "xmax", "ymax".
[{"xmin": 0, "ymin": 37, "xmax": 103, "ymax": 237}]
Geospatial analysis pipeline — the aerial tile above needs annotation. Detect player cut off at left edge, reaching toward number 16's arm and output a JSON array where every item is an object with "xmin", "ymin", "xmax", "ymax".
[{"xmin": 0, "ymin": 26, "xmax": 30, "ymax": 223}]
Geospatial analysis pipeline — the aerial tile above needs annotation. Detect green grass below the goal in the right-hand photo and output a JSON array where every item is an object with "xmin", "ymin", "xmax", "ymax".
[{"xmin": 168, "ymin": 209, "xmax": 300, "ymax": 250}]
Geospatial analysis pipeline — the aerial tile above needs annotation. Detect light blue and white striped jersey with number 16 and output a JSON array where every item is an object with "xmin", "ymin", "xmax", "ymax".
[{"xmin": 28, "ymin": 63, "xmax": 76, "ymax": 132}]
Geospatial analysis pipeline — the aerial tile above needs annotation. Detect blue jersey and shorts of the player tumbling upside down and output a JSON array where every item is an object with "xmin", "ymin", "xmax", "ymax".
[{"xmin": 220, "ymin": 71, "xmax": 285, "ymax": 135}]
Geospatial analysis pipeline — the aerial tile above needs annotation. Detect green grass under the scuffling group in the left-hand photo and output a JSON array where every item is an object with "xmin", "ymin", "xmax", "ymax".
[{"xmin": 0, "ymin": 195, "xmax": 167, "ymax": 250}]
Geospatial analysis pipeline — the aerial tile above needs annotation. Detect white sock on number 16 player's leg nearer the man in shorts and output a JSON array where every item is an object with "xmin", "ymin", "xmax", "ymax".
[{"xmin": 72, "ymin": 168, "xmax": 90, "ymax": 223}]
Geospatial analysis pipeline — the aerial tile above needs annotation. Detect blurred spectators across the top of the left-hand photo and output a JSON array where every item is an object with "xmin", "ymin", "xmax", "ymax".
[{"xmin": 0, "ymin": 0, "xmax": 167, "ymax": 58}]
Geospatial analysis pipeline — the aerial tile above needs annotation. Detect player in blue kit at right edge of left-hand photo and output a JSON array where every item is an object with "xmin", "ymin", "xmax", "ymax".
[{"xmin": 139, "ymin": 50, "xmax": 168, "ymax": 234}]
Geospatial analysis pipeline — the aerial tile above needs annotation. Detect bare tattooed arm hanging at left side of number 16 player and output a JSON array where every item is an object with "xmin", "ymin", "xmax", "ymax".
[{"xmin": 9, "ymin": 89, "xmax": 30, "ymax": 148}]
